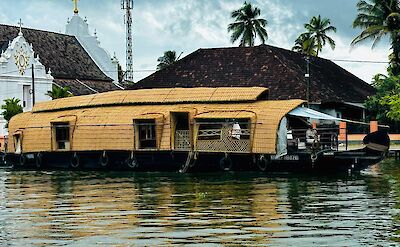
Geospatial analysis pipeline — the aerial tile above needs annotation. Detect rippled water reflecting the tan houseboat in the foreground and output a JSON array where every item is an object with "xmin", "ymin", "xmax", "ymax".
[{"xmin": 0, "ymin": 170, "xmax": 400, "ymax": 246}]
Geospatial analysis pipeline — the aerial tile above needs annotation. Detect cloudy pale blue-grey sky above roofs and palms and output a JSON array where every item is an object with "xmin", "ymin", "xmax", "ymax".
[{"xmin": 0, "ymin": 0, "xmax": 389, "ymax": 82}]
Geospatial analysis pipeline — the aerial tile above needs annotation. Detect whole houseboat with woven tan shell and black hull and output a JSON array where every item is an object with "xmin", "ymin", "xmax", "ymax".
[{"xmin": 6, "ymin": 87, "xmax": 389, "ymax": 172}]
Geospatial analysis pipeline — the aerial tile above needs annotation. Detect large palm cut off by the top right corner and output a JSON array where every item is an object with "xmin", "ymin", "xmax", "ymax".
[{"xmin": 351, "ymin": 0, "xmax": 400, "ymax": 75}]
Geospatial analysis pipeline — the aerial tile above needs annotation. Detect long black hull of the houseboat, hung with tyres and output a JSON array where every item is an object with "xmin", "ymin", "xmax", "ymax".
[{"xmin": 2, "ymin": 149, "xmax": 384, "ymax": 172}]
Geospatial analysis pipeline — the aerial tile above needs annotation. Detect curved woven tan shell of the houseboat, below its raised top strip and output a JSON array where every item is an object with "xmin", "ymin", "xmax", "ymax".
[{"xmin": 9, "ymin": 97, "xmax": 304, "ymax": 154}]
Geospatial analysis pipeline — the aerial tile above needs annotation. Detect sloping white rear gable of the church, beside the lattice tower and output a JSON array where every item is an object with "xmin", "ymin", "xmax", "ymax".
[{"xmin": 65, "ymin": 13, "xmax": 118, "ymax": 84}]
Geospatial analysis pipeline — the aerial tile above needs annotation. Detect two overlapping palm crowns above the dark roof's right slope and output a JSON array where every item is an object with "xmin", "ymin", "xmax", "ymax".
[{"xmin": 292, "ymin": 15, "xmax": 336, "ymax": 56}]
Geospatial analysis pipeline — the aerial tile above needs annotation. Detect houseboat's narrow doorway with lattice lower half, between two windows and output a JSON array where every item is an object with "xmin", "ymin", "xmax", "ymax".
[{"xmin": 171, "ymin": 112, "xmax": 191, "ymax": 151}]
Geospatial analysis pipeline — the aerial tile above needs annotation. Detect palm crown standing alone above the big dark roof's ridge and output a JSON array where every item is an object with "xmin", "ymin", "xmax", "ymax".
[{"xmin": 228, "ymin": 2, "xmax": 268, "ymax": 46}]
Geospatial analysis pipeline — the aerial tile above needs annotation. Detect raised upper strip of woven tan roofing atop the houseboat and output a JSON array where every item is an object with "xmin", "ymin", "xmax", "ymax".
[{"xmin": 33, "ymin": 87, "xmax": 268, "ymax": 112}]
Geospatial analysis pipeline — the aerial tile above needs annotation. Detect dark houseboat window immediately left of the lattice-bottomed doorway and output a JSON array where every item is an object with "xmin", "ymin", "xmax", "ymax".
[{"xmin": 136, "ymin": 120, "xmax": 157, "ymax": 149}]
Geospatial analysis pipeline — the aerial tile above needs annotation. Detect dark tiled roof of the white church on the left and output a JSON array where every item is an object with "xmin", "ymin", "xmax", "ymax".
[{"xmin": 0, "ymin": 24, "xmax": 121, "ymax": 95}]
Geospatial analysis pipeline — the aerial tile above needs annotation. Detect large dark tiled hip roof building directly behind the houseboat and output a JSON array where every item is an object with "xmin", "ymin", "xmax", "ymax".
[{"xmin": 131, "ymin": 45, "xmax": 375, "ymax": 123}]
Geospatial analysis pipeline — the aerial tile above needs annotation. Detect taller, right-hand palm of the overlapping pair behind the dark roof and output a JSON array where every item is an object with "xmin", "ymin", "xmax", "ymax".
[{"xmin": 304, "ymin": 15, "xmax": 336, "ymax": 56}]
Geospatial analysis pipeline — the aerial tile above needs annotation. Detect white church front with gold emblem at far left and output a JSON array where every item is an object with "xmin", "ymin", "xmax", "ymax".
[{"xmin": 0, "ymin": 32, "xmax": 53, "ymax": 136}]
